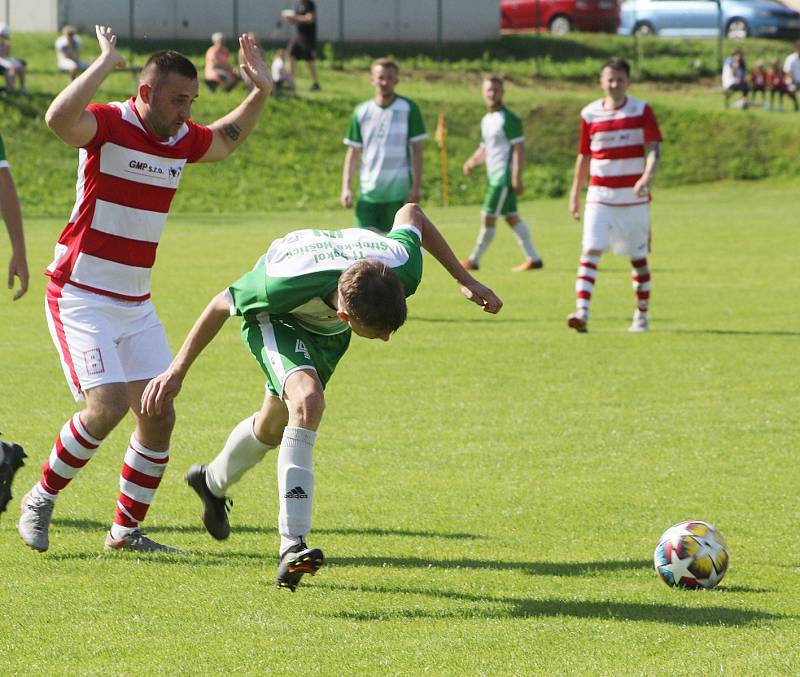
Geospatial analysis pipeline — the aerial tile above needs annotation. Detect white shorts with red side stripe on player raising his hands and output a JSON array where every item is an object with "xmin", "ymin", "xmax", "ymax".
[{"xmin": 45, "ymin": 283, "xmax": 172, "ymax": 401}]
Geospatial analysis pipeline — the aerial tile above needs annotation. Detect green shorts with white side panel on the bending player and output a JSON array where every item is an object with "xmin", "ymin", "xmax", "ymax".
[{"xmin": 242, "ymin": 313, "xmax": 352, "ymax": 399}]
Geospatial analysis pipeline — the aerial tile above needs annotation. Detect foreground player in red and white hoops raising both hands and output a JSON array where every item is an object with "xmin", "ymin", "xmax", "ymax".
[{"xmin": 19, "ymin": 26, "xmax": 271, "ymax": 551}]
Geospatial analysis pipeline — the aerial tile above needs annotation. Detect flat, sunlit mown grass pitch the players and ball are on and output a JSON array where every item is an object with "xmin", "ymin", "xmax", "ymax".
[{"xmin": 0, "ymin": 182, "xmax": 800, "ymax": 675}]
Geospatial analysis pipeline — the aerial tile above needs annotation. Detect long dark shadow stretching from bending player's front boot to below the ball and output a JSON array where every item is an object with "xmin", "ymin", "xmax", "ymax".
[{"xmin": 315, "ymin": 583, "xmax": 792, "ymax": 627}]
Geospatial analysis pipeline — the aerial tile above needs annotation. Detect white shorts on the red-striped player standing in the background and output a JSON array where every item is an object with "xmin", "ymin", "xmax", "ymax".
[{"xmin": 583, "ymin": 202, "xmax": 650, "ymax": 259}]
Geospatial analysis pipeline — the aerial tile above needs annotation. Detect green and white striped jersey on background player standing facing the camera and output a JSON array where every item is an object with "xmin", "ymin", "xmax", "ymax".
[{"xmin": 344, "ymin": 96, "xmax": 428, "ymax": 202}]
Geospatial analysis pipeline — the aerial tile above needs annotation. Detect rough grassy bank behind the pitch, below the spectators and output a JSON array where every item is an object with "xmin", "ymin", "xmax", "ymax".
[{"xmin": 0, "ymin": 34, "xmax": 800, "ymax": 217}]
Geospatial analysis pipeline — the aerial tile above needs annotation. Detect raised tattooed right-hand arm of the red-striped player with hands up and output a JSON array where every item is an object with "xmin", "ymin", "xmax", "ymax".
[{"xmin": 200, "ymin": 34, "xmax": 272, "ymax": 162}]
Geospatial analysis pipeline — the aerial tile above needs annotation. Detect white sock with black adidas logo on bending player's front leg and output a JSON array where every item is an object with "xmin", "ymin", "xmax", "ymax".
[{"xmin": 278, "ymin": 426, "xmax": 317, "ymax": 553}]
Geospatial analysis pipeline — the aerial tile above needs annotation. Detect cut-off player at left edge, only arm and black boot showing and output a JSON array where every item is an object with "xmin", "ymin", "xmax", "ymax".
[{"xmin": 0, "ymin": 128, "xmax": 28, "ymax": 513}]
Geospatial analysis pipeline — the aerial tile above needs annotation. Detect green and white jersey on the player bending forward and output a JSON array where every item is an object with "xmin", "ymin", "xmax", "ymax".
[{"xmin": 227, "ymin": 225, "xmax": 422, "ymax": 335}]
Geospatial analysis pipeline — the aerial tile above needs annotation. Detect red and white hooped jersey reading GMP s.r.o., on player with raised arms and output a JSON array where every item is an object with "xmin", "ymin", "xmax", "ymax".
[{"xmin": 47, "ymin": 98, "xmax": 212, "ymax": 301}]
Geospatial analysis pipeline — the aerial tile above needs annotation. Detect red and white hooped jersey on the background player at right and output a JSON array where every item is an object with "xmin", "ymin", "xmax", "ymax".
[{"xmin": 578, "ymin": 96, "xmax": 661, "ymax": 207}]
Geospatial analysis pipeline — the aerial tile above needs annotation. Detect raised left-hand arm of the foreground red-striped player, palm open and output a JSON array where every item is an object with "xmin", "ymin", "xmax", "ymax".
[{"xmin": 44, "ymin": 26, "xmax": 125, "ymax": 148}]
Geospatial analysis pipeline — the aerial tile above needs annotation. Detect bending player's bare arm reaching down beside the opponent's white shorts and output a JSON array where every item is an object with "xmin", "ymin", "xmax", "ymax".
[{"xmin": 142, "ymin": 292, "xmax": 230, "ymax": 415}]
